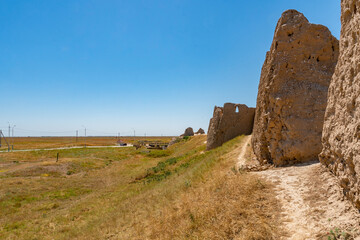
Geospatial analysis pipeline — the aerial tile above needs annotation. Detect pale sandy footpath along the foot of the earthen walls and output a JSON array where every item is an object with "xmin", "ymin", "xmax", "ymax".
[{"xmin": 238, "ymin": 136, "xmax": 360, "ymax": 240}]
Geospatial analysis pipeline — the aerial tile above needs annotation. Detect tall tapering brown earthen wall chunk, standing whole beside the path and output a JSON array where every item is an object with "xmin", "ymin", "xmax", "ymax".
[{"xmin": 252, "ymin": 10, "xmax": 339, "ymax": 166}]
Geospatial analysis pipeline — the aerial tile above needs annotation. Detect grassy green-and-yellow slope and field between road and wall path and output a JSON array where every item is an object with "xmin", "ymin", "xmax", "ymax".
[{"xmin": 0, "ymin": 136, "xmax": 279, "ymax": 239}]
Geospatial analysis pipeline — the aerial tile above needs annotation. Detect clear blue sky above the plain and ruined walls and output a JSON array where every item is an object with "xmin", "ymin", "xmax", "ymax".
[{"xmin": 0, "ymin": 0, "xmax": 340, "ymax": 135}]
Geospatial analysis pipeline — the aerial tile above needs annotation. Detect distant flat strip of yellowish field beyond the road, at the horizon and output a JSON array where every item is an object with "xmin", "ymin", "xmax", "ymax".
[{"xmin": 0, "ymin": 137, "xmax": 172, "ymax": 150}]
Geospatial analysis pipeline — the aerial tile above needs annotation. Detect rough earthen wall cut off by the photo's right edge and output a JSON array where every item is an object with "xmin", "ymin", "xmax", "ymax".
[{"xmin": 319, "ymin": 0, "xmax": 360, "ymax": 208}]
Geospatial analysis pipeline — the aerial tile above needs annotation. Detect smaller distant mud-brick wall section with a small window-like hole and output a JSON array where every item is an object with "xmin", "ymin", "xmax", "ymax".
[{"xmin": 206, "ymin": 103, "xmax": 255, "ymax": 150}]
